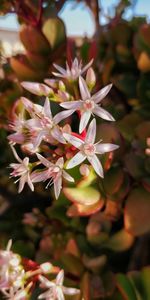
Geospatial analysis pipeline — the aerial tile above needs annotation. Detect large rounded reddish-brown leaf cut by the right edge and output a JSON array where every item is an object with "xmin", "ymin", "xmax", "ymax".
[{"xmin": 124, "ymin": 188, "xmax": 150, "ymax": 236}]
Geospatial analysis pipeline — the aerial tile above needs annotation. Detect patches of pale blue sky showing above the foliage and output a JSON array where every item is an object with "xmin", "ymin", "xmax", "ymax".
[{"xmin": 0, "ymin": 0, "xmax": 150, "ymax": 37}]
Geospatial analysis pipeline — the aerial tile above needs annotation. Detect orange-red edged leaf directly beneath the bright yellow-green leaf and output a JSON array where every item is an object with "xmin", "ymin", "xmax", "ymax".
[{"xmin": 67, "ymin": 199, "xmax": 104, "ymax": 217}]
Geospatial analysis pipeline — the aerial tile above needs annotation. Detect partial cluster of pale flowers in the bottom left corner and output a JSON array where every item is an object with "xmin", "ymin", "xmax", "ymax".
[{"xmin": 0, "ymin": 240, "xmax": 80, "ymax": 300}]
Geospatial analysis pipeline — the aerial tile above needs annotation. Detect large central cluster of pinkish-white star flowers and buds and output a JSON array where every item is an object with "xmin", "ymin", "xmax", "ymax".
[{"xmin": 8, "ymin": 59, "xmax": 118, "ymax": 198}]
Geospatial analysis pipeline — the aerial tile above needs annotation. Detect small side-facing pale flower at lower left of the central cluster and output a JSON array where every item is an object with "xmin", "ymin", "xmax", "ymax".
[{"xmin": 10, "ymin": 146, "xmax": 34, "ymax": 193}]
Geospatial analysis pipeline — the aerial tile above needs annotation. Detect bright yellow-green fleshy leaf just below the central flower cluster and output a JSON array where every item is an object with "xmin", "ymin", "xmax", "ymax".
[{"xmin": 63, "ymin": 187, "xmax": 101, "ymax": 205}]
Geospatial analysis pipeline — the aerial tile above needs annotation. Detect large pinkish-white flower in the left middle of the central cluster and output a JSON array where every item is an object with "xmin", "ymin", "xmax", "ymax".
[{"xmin": 22, "ymin": 97, "xmax": 72, "ymax": 149}]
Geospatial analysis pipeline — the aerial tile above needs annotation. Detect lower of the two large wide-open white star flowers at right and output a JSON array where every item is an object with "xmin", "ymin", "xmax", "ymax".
[{"xmin": 64, "ymin": 119, "xmax": 118, "ymax": 177}]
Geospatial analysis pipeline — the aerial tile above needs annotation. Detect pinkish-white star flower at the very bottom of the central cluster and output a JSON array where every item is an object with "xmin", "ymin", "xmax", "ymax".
[{"xmin": 32, "ymin": 154, "xmax": 74, "ymax": 199}]
